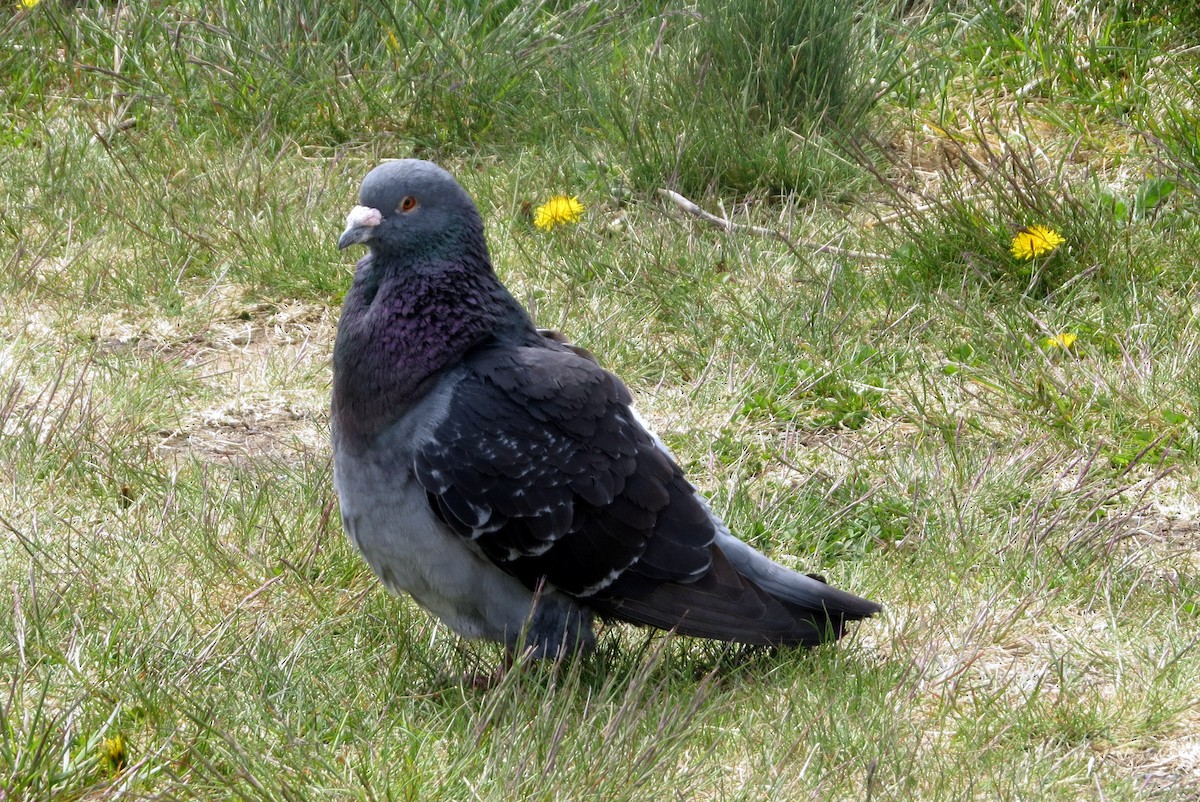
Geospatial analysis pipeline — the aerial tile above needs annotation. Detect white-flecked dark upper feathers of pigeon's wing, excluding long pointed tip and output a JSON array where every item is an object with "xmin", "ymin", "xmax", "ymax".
[{"xmin": 414, "ymin": 347, "xmax": 700, "ymax": 594}]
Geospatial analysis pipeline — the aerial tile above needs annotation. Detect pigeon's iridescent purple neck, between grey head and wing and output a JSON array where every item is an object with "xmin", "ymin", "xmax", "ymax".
[{"xmin": 332, "ymin": 256, "xmax": 536, "ymax": 445}]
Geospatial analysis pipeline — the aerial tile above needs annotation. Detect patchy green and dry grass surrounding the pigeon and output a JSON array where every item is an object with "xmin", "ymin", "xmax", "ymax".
[{"xmin": 0, "ymin": 0, "xmax": 1200, "ymax": 801}]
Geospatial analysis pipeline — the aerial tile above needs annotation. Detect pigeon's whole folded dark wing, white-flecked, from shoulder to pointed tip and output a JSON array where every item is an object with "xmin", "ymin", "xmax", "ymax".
[{"xmin": 415, "ymin": 346, "xmax": 877, "ymax": 644}]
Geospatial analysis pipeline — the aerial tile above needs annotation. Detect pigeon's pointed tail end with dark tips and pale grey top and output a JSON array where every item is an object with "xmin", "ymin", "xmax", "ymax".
[{"xmin": 594, "ymin": 533, "xmax": 882, "ymax": 646}]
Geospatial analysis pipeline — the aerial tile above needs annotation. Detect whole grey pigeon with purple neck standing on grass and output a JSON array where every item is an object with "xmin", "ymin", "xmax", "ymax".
[{"xmin": 331, "ymin": 158, "xmax": 881, "ymax": 658}]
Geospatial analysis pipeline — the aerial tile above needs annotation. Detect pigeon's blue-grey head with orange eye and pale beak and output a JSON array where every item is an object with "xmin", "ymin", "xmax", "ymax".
[{"xmin": 337, "ymin": 158, "xmax": 484, "ymax": 258}]
